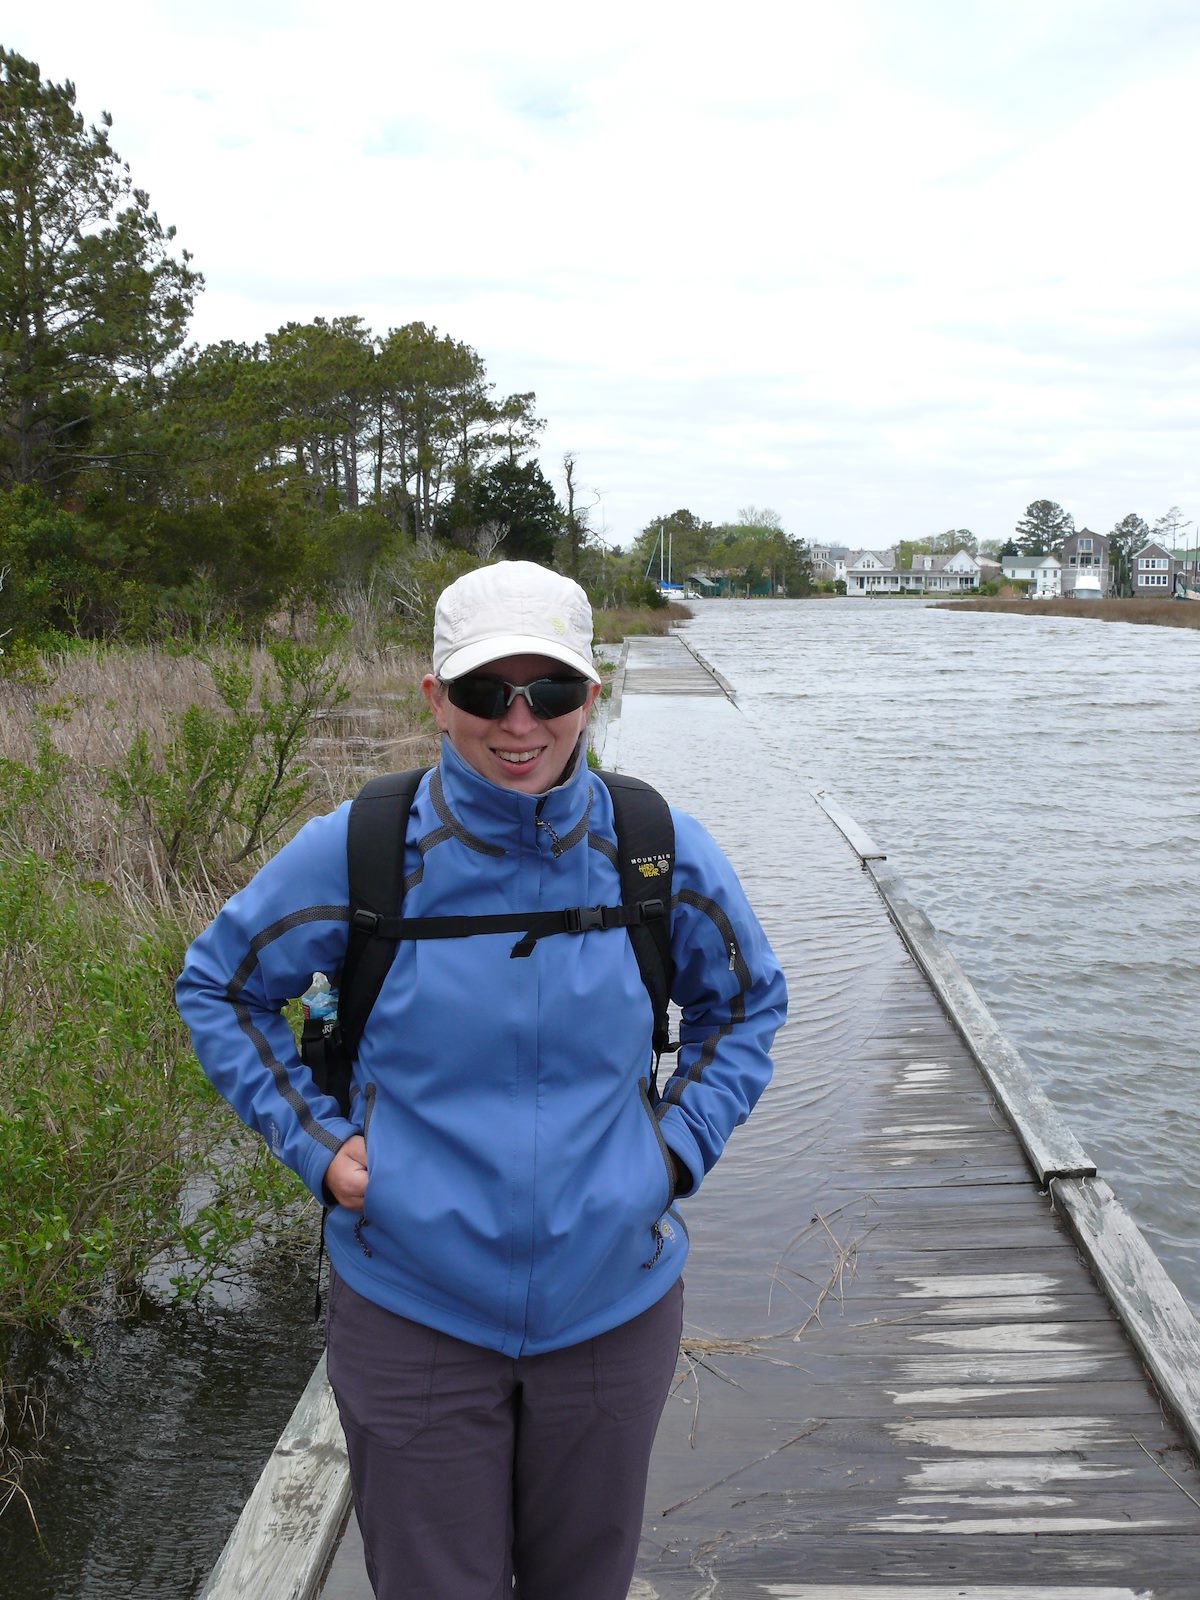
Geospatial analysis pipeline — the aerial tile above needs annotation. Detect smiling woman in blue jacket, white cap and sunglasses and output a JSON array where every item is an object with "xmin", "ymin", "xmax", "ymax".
[{"xmin": 178, "ymin": 562, "xmax": 786, "ymax": 1600}]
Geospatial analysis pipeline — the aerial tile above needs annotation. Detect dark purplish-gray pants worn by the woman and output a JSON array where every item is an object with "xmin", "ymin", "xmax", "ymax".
[{"xmin": 328, "ymin": 1274, "xmax": 683, "ymax": 1600}]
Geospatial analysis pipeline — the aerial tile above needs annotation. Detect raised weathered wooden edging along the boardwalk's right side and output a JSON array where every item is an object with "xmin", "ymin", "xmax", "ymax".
[{"xmin": 813, "ymin": 789, "xmax": 1200, "ymax": 1453}]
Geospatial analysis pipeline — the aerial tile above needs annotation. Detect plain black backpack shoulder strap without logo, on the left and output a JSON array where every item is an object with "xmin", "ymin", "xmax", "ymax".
[{"xmin": 338, "ymin": 766, "xmax": 429, "ymax": 1059}]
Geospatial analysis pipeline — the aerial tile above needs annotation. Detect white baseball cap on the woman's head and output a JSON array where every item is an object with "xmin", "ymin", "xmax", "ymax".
[{"xmin": 434, "ymin": 562, "xmax": 600, "ymax": 683}]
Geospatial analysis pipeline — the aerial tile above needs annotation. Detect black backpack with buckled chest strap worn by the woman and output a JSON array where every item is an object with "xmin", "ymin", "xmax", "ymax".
[{"xmin": 301, "ymin": 766, "xmax": 678, "ymax": 1117}]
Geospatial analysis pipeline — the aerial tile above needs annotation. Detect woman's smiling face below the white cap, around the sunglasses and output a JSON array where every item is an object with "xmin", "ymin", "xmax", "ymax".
[{"xmin": 421, "ymin": 656, "xmax": 600, "ymax": 795}]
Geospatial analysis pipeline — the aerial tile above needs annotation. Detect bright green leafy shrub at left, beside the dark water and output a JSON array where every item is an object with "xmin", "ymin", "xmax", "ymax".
[{"xmin": 0, "ymin": 856, "xmax": 299, "ymax": 1331}]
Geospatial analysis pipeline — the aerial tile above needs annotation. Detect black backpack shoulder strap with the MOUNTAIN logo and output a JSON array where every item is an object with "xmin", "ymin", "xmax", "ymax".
[{"xmin": 597, "ymin": 771, "xmax": 675, "ymax": 1061}]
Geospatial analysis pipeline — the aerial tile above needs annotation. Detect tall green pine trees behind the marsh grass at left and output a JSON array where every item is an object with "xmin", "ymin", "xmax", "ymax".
[{"xmin": 0, "ymin": 48, "xmax": 659, "ymax": 643}]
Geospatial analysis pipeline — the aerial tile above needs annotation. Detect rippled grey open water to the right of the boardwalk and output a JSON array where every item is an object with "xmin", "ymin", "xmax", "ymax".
[{"xmin": 685, "ymin": 600, "xmax": 1200, "ymax": 1309}]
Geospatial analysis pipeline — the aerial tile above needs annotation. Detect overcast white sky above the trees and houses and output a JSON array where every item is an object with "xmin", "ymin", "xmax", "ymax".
[{"xmin": 9, "ymin": 0, "xmax": 1200, "ymax": 547}]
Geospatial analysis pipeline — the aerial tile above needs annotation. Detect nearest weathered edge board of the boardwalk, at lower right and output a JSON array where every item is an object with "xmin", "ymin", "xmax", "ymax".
[{"xmin": 1054, "ymin": 1178, "xmax": 1200, "ymax": 1451}]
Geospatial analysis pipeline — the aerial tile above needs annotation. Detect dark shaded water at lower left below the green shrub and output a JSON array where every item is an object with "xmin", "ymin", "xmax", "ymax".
[{"xmin": 0, "ymin": 1235, "xmax": 322, "ymax": 1600}]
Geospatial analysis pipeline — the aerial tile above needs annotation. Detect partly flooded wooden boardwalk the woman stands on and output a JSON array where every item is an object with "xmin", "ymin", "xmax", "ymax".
[{"xmin": 202, "ymin": 638, "xmax": 1200, "ymax": 1600}]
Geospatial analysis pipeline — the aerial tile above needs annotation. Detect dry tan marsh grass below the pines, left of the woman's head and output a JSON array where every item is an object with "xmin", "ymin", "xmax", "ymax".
[{"xmin": 0, "ymin": 633, "xmax": 435, "ymax": 926}]
